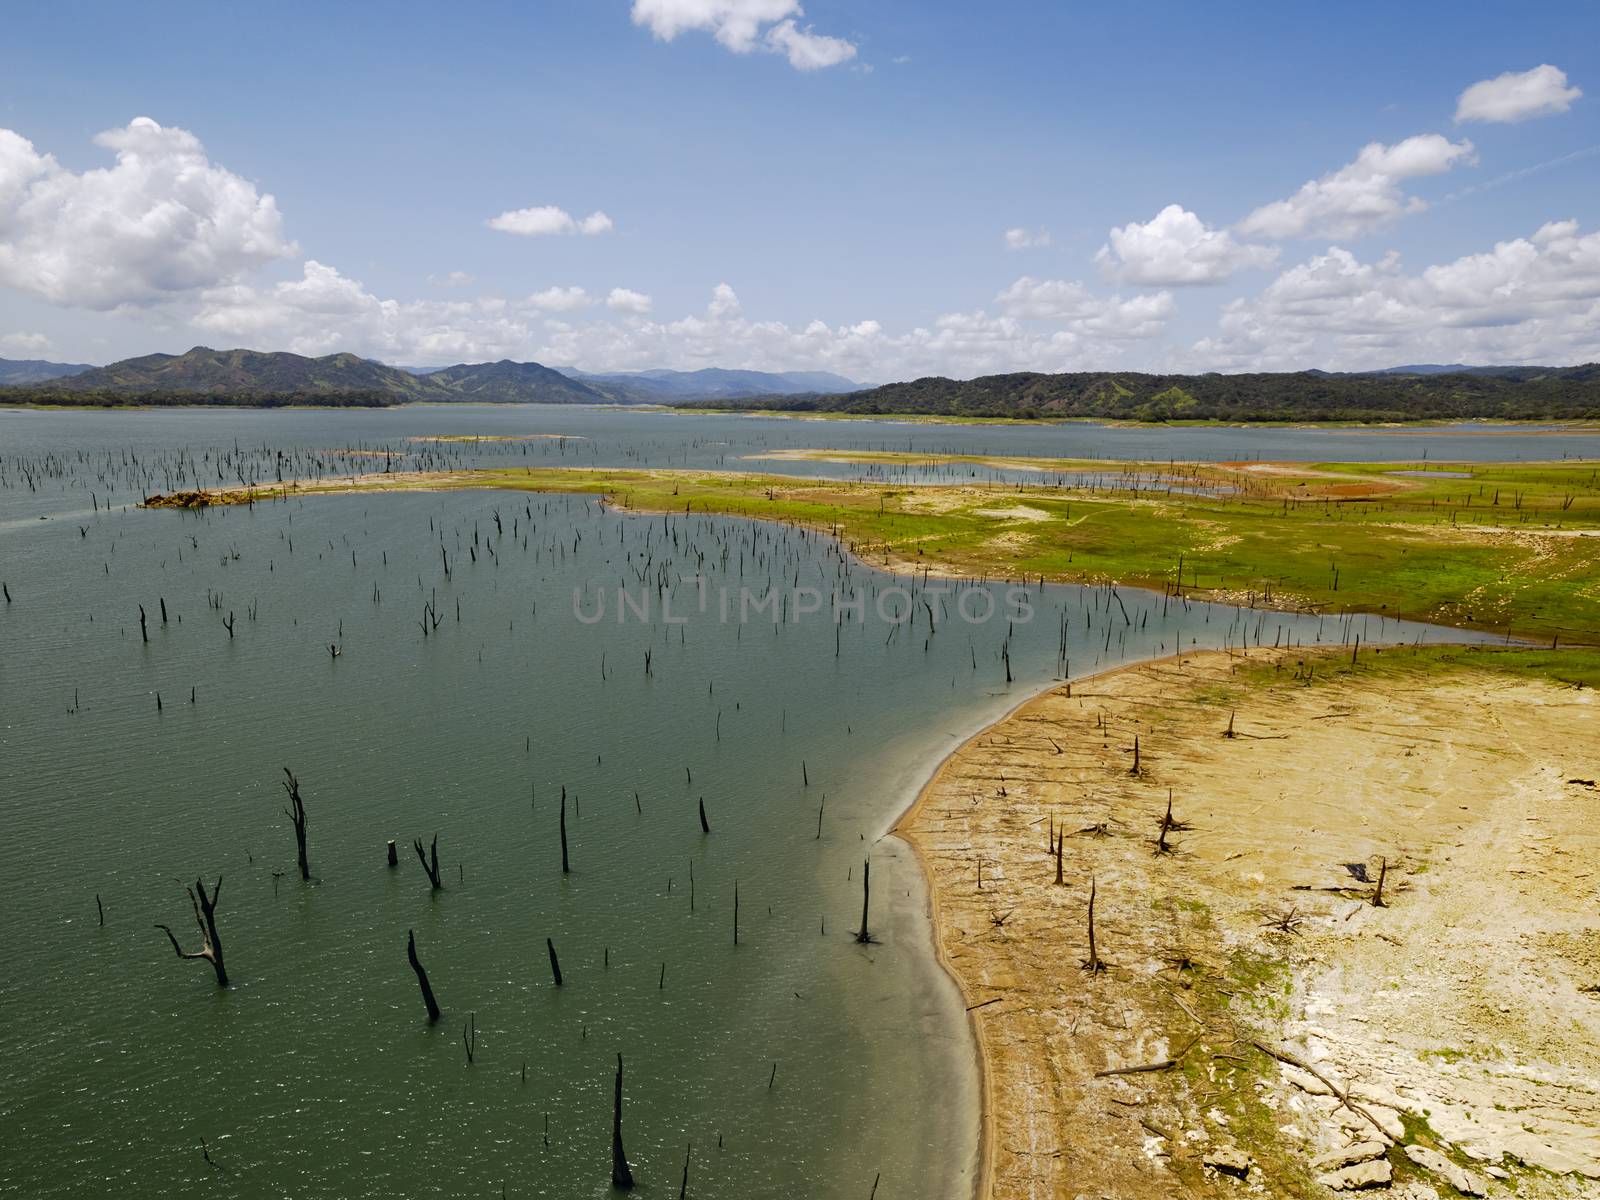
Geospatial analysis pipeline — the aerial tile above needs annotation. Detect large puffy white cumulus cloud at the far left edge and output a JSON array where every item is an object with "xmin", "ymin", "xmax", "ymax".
[{"xmin": 0, "ymin": 117, "xmax": 296, "ymax": 309}]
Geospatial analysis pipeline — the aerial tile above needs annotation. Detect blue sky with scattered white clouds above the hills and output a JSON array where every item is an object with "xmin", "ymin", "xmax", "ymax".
[{"xmin": 0, "ymin": 0, "xmax": 1600, "ymax": 381}]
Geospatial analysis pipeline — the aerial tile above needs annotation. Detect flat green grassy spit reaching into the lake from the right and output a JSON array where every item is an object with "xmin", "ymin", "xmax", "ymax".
[{"xmin": 175, "ymin": 451, "xmax": 1600, "ymax": 643}]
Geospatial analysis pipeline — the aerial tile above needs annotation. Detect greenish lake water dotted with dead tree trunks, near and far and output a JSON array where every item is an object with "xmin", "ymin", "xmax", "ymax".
[{"xmin": 0, "ymin": 408, "xmax": 1523, "ymax": 1200}]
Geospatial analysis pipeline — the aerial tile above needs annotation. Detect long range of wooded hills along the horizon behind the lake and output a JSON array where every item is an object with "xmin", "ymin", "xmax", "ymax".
[{"xmin": 0, "ymin": 346, "xmax": 1600, "ymax": 421}]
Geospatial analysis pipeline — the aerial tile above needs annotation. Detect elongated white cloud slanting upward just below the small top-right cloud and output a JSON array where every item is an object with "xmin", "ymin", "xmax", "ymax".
[{"xmin": 1238, "ymin": 133, "xmax": 1477, "ymax": 238}]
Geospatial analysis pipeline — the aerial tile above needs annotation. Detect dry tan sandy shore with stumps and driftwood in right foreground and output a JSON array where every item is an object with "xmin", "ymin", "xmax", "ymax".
[{"xmin": 899, "ymin": 650, "xmax": 1600, "ymax": 1200}]
